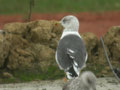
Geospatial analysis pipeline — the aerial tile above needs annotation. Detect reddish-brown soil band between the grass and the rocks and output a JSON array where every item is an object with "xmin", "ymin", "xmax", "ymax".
[{"xmin": 0, "ymin": 12, "xmax": 120, "ymax": 37}]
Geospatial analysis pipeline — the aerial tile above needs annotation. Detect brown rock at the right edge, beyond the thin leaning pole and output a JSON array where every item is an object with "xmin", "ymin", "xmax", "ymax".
[{"xmin": 104, "ymin": 26, "xmax": 120, "ymax": 64}]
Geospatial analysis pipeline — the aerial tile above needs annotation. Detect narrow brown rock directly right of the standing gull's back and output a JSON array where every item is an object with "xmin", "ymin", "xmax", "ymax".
[{"xmin": 82, "ymin": 32, "xmax": 99, "ymax": 62}]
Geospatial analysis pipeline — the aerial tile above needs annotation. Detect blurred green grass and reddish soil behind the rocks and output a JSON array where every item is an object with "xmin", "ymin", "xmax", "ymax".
[{"xmin": 0, "ymin": 0, "xmax": 120, "ymax": 37}]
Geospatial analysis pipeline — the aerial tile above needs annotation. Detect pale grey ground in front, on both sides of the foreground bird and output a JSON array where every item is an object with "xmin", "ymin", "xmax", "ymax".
[{"xmin": 0, "ymin": 77, "xmax": 120, "ymax": 90}]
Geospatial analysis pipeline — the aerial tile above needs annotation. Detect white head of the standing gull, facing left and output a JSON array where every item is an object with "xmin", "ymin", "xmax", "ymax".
[{"xmin": 61, "ymin": 15, "xmax": 79, "ymax": 31}]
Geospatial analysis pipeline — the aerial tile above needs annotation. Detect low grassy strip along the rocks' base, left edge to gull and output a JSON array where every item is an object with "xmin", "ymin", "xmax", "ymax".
[{"xmin": 0, "ymin": 66, "xmax": 65, "ymax": 83}]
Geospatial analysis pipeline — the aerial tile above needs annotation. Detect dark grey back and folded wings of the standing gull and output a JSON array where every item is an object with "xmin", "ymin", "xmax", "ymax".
[{"xmin": 57, "ymin": 34, "xmax": 86, "ymax": 70}]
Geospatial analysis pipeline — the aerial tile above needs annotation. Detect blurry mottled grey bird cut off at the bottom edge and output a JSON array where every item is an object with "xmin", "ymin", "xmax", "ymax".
[{"xmin": 62, "ymin": 71, "xmax": 96, "ymax": 90}]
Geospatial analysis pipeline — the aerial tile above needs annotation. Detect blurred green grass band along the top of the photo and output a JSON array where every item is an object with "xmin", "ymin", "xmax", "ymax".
[{"xmin": 0, "ymin": 0, "xmax": 120, "ymax": 14}]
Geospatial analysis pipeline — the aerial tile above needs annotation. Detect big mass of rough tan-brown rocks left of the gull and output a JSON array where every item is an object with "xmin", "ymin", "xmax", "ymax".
[{"xmin": 0, "ymin": 20, "xmax": 63, "ymax": 72}]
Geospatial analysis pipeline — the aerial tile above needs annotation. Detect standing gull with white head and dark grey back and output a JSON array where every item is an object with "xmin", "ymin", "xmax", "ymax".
[{"xmin": 55, "ymin": 15, "xmax": 88, "ymax": 79}]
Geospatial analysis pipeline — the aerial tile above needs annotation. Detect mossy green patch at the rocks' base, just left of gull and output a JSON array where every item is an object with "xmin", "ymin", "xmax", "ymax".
[{"xmin": 13, "ymin": 66, "xmax": 64, "ymax": 82}]
